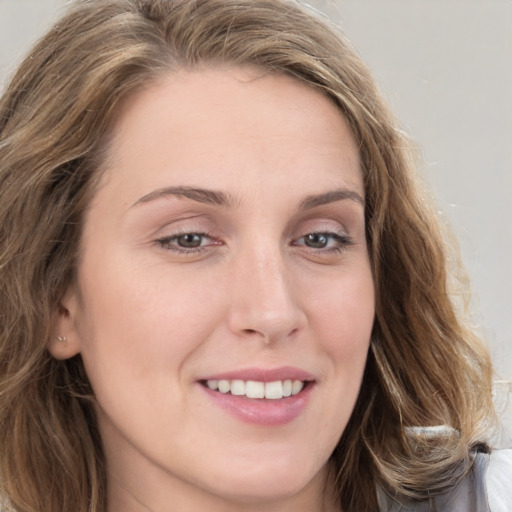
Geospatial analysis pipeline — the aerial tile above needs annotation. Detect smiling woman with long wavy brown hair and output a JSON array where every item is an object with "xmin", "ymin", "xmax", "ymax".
[{"xmin": 0, "ymin": 0, "xmax": 506, "ymax": 512}]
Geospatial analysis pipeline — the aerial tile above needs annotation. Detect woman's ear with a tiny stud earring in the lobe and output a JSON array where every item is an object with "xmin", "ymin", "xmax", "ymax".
[{"xmin": 48, "ymin": 291, "xmax": 81, "ymax": 359}]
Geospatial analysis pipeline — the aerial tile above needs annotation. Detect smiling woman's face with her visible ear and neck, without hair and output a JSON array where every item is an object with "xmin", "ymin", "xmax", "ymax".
[{"xmin": 55, "ymin": 68, "xmax": 374, "ymax": 511}]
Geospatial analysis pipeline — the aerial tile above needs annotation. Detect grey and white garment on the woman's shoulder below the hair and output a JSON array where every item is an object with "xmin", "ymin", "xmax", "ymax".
[{"xmin": 378, "ymin": 450, "xmax": 512, "ymax": 512}]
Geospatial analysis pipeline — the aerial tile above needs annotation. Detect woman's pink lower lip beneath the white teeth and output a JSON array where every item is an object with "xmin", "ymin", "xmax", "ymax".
[{"xmin": 199, "ymin": 382, "xmax": 314, "ymax": 427}]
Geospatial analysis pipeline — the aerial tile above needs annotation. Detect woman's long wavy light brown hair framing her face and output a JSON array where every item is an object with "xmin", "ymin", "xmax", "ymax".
[{"xmin": 0, "ymin": 0, "xmax": 492, "ymax": 512}]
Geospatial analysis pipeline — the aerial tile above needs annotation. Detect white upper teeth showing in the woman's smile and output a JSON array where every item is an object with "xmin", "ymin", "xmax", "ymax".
[{"xmin": 206, "ymin": 380, "xmax": 304, "ymax": 400}]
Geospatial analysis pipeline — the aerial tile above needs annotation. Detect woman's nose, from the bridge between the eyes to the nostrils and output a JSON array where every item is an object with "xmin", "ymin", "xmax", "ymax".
[{"xmin": 228, "ymin": 244, "xmax": 307, "ymax": 344}]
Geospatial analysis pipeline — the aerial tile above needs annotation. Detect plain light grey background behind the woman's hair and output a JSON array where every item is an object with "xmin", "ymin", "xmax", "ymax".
[{"xmin": 0, "ymin": 0, "xmax": 512, "ymax": 440}]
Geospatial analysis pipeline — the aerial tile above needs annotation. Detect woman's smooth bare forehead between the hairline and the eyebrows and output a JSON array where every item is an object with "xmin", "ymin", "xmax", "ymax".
[{"xmin": 95, "ymin": 67, "xmax": 364, "ymax": 208}]
